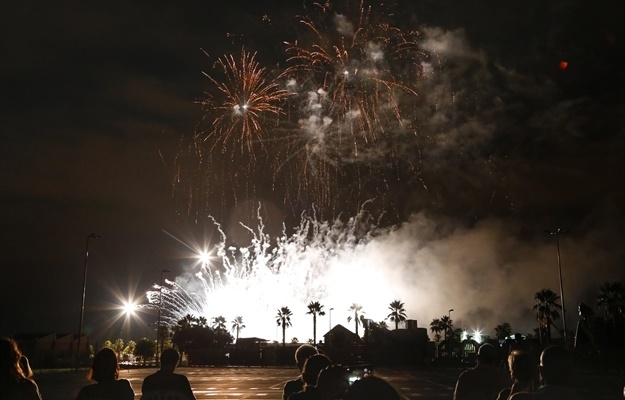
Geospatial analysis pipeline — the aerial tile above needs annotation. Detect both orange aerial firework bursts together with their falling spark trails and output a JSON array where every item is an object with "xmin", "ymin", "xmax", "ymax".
[{"xmin": 175, "ymin": 1, "xmax": 423, "ymax": 217}]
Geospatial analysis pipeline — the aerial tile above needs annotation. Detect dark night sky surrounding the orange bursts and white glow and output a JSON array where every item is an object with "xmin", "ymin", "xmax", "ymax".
[{"xmin": 0, "ymin": 0, "xmax": 625, "ymax": 344}]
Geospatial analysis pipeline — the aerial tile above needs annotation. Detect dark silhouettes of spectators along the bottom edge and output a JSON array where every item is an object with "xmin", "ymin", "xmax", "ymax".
[{"xmin": 0, "ymin": 330, "xmax": 625, "ymax": 400}]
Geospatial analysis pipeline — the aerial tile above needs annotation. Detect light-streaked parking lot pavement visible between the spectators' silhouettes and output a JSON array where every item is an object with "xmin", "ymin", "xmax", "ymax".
[{"xmin": 35, "ymin": 367, "xmax": 625, "ymax": 400}]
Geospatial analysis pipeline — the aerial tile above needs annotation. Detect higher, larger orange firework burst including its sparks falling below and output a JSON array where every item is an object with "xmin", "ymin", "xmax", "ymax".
[{"xmin": 276, "ymin": 1, "xmax": 423, "ymax": 216}]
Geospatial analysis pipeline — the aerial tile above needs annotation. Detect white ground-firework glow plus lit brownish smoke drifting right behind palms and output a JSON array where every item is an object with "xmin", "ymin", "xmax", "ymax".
[{"xmin": 148, "ymin": 203, "xmax": 619, "ymax": 341}]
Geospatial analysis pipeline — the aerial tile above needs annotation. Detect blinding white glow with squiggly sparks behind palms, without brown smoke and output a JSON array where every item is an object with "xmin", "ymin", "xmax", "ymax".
[{"xmin": 147, "ymin": 208, "xmax": 410, "ymax": 342}]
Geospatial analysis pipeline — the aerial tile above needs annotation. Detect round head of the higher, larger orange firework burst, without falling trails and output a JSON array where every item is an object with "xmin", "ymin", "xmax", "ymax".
[{"xmin": 287, "ymin": 2, "xmax": 422, "ymax": 152}]
